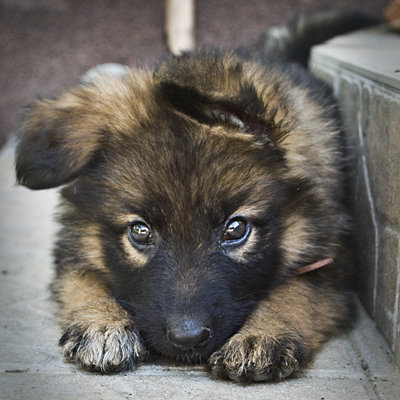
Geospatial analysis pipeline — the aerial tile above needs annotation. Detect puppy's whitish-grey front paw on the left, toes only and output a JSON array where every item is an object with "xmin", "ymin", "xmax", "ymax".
[{"xmin": 59, "ymin": 324, "xmax": 147, "ymax": 373}]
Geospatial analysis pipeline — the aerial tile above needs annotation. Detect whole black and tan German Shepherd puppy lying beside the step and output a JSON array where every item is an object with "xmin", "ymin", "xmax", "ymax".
[{"xmin": 16, "ymin": 12, "xmax": 376, "ymax": 381}]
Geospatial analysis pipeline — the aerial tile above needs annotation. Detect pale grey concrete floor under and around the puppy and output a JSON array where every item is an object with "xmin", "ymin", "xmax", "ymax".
[{"xmin": 0, "ymin": 142, "xmax": 400, "ymax": 400}]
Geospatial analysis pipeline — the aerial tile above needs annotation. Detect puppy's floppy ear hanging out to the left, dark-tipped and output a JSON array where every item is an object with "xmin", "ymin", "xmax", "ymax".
[{"xmin": 16, "ymin": 86, "xmax": 104, "ymax": 189}]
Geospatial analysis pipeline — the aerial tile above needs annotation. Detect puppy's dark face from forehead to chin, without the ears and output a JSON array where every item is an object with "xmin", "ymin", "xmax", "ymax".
[{"xmin": 95, "ymin": 129, "xmax": 282, "ymax": 357}]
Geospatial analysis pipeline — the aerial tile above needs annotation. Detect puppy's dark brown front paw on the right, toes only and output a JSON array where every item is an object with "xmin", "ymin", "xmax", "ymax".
[{"xmin": 208, "ymin": 333, "xmax": 308, "ymax": 382}]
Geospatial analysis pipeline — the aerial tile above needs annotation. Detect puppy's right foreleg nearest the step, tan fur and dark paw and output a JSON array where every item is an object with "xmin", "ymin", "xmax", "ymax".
[{"xmin": 208, "ymin": 276, "xmax": 349, "ymax": 381}]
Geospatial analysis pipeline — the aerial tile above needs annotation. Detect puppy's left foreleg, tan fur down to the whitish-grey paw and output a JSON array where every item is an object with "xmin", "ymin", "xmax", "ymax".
[{"xmin": 54, "ymin": 270, "xmax": 146, "ymax": 372}]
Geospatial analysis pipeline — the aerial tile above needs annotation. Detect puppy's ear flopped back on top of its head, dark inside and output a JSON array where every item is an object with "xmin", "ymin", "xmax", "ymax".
[{"xmin": 154, "ymin": 52, "xmax": 282, "ymax": 141}]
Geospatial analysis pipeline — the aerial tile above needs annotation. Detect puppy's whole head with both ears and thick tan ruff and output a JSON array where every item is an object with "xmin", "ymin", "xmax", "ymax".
[{"xmin": 16, "ymin": 54, "xmax": 342, "ymax": 359}]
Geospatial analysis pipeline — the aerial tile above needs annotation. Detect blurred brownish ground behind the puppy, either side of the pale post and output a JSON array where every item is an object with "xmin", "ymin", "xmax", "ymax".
[{"xmin": 0, "ymin": 0, "xmax": 394, "ymax": 146}]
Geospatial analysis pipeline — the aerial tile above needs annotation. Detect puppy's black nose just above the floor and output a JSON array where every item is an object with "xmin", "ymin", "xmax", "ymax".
[{"xmin": 167, "ymin": 320, "xmax": 211, "ymax": 350}]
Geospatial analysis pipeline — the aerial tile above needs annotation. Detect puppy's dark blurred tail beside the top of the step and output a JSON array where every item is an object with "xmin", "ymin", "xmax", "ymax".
[{"xmin": 262, "ymin": 9, "xmax": 382, "ymax": 66}]
